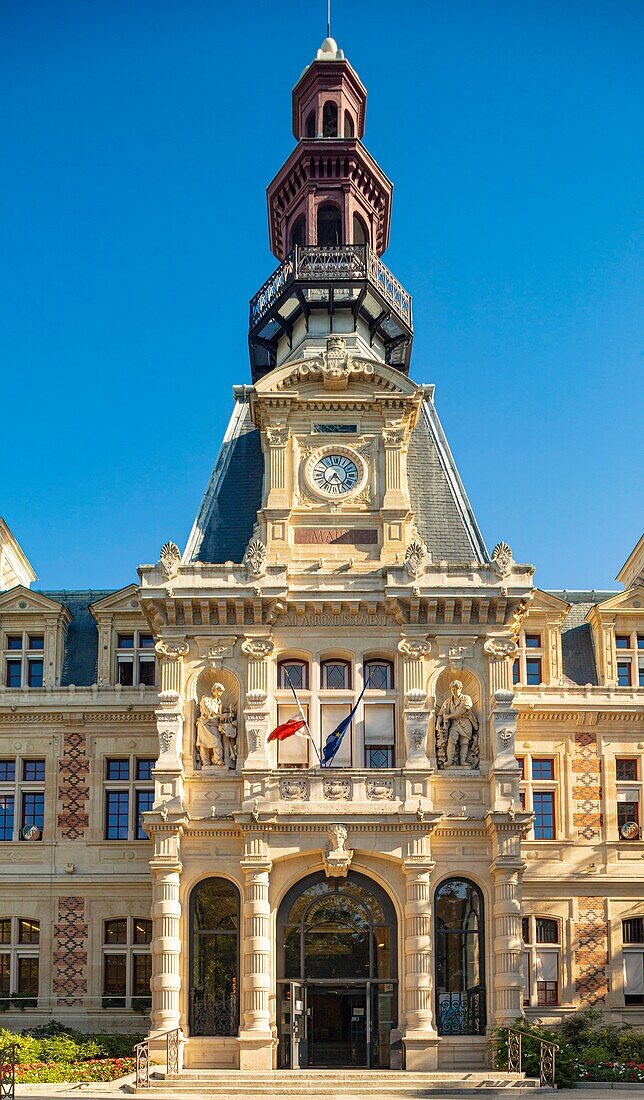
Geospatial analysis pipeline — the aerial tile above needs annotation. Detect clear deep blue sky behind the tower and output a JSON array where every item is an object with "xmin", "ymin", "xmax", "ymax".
[{"xmin": 0, "ymin": 0, "xmax": 644, "ymax": 589}]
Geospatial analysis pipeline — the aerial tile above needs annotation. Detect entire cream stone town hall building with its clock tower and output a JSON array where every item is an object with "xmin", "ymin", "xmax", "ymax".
[{"xmin": 0, "ymin": 32, "xmax": 644, "ymax": 1069}]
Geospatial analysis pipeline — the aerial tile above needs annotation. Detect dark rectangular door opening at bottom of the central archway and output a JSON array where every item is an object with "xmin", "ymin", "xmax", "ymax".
[{"xmin": 307, "ymin": 986, "xmax": 369, "ymax": 1067}]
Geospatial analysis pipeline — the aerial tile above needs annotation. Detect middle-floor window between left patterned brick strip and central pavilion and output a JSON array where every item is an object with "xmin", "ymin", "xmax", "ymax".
[{"xmin": 105, "ymin": 757, "xmax": 155, "ymax": 840}]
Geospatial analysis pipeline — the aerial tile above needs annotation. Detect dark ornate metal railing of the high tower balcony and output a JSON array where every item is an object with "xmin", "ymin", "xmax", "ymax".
[{"xmin": 250, "ymin": 244, "xmax": 412, "ymax": 328}]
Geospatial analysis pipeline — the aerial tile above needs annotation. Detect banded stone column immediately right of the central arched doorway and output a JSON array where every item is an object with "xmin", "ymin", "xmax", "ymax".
[{"xmin": 403, "ymin": 837, "xmax": 438, "ymax": 1070}]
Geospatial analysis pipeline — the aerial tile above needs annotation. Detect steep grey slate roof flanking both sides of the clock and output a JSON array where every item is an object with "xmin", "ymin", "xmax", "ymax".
[{"xmin": 184, "ymin": 396, "xmax": 489, "ymax": 564}]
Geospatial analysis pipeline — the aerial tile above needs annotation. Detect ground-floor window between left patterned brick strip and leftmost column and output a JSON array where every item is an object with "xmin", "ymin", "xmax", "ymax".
[{"xmin": 102, "ymin": 916, "xmax": 152, "ymax": 1009}]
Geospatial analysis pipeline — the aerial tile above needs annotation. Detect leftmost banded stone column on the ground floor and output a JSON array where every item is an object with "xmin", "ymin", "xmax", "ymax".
[{"xmin": 150, "ymin": 820, "xmax": 185, "ymax": 1057}]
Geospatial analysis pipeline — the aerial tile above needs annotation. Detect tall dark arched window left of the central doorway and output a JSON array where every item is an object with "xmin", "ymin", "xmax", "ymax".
[{"xmin": 190, "ymin": 879, "xmax": 239, "ymax": 1035}]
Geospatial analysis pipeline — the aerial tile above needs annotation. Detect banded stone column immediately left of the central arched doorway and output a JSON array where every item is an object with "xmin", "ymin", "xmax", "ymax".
[{"xmin": 239, "ymin": 836, "xmax": 274, "ymax": 1069}]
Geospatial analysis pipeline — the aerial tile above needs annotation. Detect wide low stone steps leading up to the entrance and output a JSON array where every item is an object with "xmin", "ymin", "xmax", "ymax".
[{"xmin": 124, "ymin": 1069, "xmax": 554, "ymax": 1100}]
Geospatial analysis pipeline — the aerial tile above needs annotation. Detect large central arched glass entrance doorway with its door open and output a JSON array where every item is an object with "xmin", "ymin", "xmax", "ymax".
[{"xmin": 277, "ymin": 871, "xmax": 397, "ymax": 1069}]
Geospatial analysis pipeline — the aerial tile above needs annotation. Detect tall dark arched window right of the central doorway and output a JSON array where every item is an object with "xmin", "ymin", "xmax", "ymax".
[{"xmin": 434, "ymin": 879, "xmax": 485, "ymax": 1035}]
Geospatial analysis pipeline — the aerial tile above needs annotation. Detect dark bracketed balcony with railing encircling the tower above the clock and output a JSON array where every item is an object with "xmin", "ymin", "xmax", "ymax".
[{"xmin": 249, "ymin": 244, "xmax": 414, "ymax": 382}]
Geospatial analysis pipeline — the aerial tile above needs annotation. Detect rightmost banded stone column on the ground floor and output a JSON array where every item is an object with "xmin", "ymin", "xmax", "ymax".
[{"xmin": 488, "ymin": 813, "xmax": 530, "ymax": 1027}]
